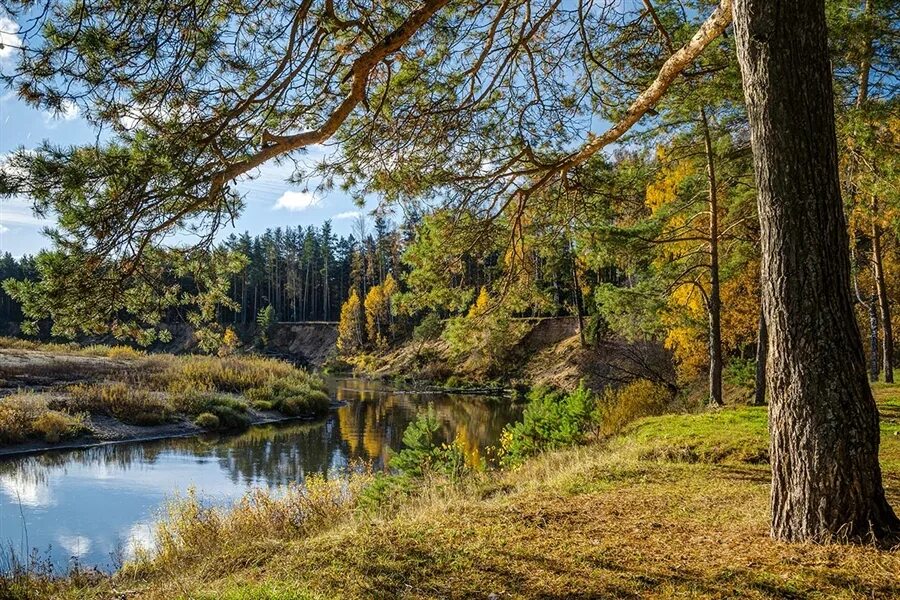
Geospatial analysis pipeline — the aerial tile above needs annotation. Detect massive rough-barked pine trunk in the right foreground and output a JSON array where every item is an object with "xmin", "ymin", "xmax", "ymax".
[{"xmin": 734, "ymin": 0, "xmax": 900, "ymax": 542}]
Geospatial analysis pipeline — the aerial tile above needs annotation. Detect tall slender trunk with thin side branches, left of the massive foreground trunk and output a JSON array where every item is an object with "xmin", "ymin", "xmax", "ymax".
[{"xmin": 700, "ymin": 108, "xmax": 724, "ymax": 406}]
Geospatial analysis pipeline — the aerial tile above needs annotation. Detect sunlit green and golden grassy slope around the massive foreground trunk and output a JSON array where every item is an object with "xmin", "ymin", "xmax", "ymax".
[{"xmin": 47, "ymin": 386, "xmax": 900, "ymax": 599}]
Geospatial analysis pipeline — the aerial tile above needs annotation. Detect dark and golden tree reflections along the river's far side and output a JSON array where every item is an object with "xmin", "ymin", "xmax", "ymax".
[{"xmin": 0, "ymin": 379, "xmax": 518, "ymax": 496}]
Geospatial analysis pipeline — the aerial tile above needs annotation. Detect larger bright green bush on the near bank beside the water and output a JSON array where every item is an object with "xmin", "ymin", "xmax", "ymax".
[{"xmin": 500, "ymin": 383, "xmax": 598, "ymax": 467}]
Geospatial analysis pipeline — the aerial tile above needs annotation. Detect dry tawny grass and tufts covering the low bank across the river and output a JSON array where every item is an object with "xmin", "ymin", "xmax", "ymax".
[{"xmin": 0, "ymin": 338, "xmax": 330, "ymax": 444}]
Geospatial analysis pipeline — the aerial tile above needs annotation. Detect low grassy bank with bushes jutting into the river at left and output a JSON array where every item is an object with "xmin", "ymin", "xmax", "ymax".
[{"xmin": 0, "ymin": 339, "xmax": 330, "ymax": 446}]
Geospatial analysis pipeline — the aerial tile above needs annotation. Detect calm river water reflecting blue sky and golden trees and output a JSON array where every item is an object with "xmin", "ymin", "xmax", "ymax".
[{"xmin": 0, "ymin": 379, "xmax": 519, "ymax": 570}]
